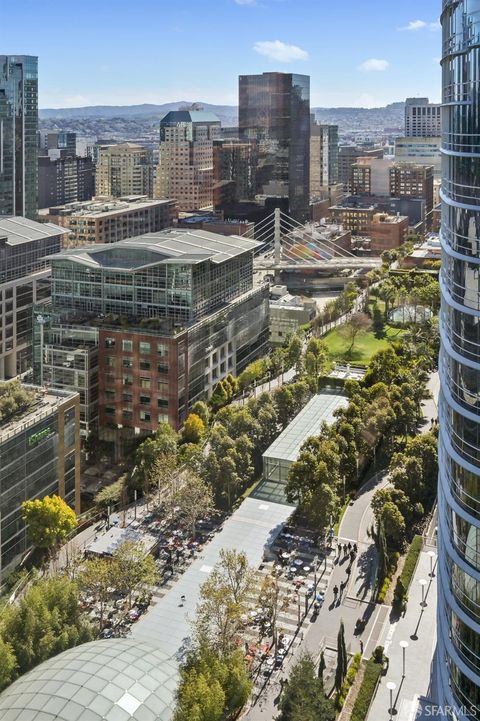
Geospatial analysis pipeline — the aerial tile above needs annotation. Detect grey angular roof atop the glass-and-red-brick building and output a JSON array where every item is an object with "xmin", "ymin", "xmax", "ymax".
[{"xmin": 50, "ymin": 228, "xmax": 260, "ymax": 270}]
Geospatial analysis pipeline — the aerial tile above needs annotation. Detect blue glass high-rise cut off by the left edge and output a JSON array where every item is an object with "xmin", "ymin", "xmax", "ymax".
[{"xmin": 0, "ymin": 55, "xmax": 38, "ymax": 220}]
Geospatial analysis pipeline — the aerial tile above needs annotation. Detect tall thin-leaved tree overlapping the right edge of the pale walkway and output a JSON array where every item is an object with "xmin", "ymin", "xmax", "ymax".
[{"xmin": 195, "ymin": 549, "xmax": 254, "ymax": 657}]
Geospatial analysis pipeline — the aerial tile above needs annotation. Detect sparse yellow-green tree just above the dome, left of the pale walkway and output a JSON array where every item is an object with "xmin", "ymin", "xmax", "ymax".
[{"xmin": 113, "ymin": 541, "xmax": 158, "ymax": 608}]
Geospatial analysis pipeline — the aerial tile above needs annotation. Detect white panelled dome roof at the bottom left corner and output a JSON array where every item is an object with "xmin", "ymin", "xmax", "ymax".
[{"xmin": 0, "ymin": 639, "xmax": 178, "ymax": 721}]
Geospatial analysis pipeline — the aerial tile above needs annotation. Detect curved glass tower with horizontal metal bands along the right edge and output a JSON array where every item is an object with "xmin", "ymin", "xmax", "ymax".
[{"xmin": 438, "ymin": 0, "xmax": 480, "ymax": 720}]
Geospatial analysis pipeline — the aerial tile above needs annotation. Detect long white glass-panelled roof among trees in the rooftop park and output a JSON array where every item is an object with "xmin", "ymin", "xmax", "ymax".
[{"xmin": 263, "ymin": 393, "xmax": 348, "ymax": 463}]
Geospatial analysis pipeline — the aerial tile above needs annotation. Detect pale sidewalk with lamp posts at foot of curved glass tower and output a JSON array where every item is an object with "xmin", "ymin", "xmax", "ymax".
[{"xmin": 367, "ymin": 551, "xmax": 437, "ymax": 721}]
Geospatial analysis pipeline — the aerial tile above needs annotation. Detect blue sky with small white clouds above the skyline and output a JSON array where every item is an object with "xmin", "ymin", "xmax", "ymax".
[{"xmin": 1, "ymin": 0, "xmax": 441, "ymax": 107}]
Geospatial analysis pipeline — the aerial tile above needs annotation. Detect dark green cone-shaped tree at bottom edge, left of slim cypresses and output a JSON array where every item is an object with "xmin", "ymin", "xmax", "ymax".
[{"xmin": 277, "ymin": 655, "xmax": 336, "ymax": 721}]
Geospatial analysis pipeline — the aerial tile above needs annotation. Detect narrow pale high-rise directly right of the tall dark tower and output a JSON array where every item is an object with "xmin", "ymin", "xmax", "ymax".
[{"xmin": 310, "ymin": 115, "xmax": 338, "ymax": 198}]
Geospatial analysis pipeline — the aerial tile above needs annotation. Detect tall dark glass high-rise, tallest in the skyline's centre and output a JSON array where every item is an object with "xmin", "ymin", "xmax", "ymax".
[{"xmin": 239, "ymin": 73, "xmax": 310, "ymax": 221}]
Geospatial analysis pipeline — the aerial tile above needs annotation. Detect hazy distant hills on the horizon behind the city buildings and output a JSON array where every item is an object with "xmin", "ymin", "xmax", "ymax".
[{"xmin": 39, "ymin": 101, "xmax": 405, "ymax": 129}]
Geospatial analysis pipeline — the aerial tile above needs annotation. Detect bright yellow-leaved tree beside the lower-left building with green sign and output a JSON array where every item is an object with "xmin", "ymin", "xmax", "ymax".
[{"xmin": 22, "ymin": 495, "xmax": 77, "ymax": 550}]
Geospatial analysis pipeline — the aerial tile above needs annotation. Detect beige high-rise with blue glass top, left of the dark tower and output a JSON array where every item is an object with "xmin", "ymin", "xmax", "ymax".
[{"xmin": 155, "ymin": 110, "xmax": 220, "ymax": 211}]
